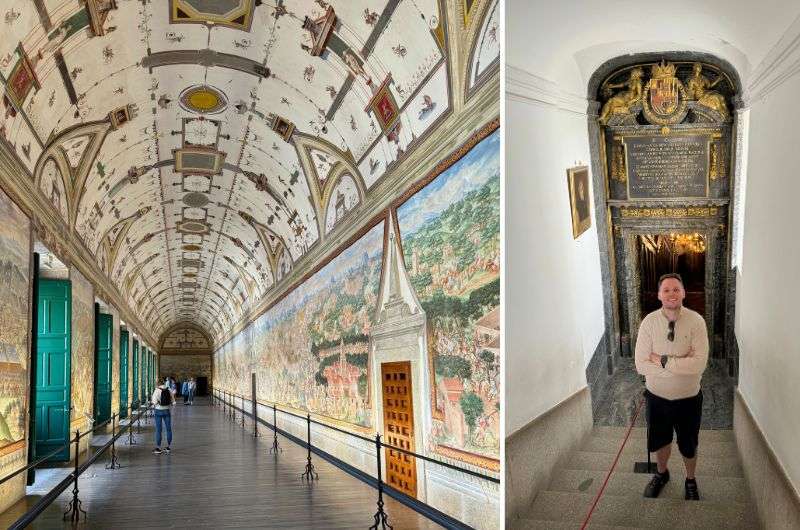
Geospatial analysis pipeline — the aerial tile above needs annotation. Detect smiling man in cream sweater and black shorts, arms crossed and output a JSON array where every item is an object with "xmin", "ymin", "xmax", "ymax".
[{"xmin": 636, "ymin": 273, "xmax": 708, "ymax": 500}]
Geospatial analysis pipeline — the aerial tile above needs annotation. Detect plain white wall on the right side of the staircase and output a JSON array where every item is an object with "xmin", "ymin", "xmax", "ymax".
[{"xmin": 736, "ymin": 70, "xmax": 800, "ymax": 490}]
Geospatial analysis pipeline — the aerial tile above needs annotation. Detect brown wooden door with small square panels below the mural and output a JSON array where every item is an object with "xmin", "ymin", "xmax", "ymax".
[{"xmin": 381, "ymin": 361, "xmax": 417, "ymax": 497}]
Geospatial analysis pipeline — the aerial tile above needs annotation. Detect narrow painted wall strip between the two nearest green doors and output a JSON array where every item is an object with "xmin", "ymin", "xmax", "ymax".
[{"xmin": 70, "ymin": 267, "xmax": 94, "ymax": 429}]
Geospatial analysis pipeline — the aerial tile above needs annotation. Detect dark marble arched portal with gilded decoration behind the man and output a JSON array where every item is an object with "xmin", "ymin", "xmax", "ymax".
[{"xmin": 589, "ymin": 52, "xmax": 740, "ymax": 375}]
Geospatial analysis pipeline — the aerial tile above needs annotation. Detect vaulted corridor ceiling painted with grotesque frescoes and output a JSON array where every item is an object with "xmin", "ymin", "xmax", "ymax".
[{"xmin": 0, "ymin": 0, "xmax": 499, "ymax": 337}]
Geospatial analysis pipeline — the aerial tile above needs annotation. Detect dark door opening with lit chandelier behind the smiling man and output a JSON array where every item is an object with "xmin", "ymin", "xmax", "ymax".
[{"xmin": 636, "ymin": 233, "xmax": 706, "ymax": 317}]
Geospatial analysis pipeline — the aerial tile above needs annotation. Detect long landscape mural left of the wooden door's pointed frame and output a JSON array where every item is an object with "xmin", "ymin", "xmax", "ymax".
[{"xmin": 214, "ymin": 222, "xmax": 384, "ymax": 427}]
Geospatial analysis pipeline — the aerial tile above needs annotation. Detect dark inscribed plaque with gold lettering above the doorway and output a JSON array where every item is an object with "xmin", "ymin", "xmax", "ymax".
[{"xmin": 624, "ymin": 134, "xmax": 709, "ymax": 199}]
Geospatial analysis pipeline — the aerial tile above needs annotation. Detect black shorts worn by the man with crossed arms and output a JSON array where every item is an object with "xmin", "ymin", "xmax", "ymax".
[{"xmin": 645, "ymin": 390, "xmax": 703, "ymax": 458}]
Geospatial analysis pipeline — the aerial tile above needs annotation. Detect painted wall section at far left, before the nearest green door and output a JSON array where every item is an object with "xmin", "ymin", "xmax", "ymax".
[{"xmin": 0, "ymin": 191, "xmax": 30, "ymax": 455}]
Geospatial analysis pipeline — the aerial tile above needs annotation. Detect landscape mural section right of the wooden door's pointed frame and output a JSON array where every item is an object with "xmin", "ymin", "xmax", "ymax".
[{"xmin": 397, "ymin": 132, "xmax": 500, "ymax": 459}]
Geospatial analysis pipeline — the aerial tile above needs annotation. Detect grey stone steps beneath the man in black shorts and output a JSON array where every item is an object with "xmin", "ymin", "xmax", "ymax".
[{"xmin": 514, "ymin": 427, "xmax": 761, "ymax": 530}]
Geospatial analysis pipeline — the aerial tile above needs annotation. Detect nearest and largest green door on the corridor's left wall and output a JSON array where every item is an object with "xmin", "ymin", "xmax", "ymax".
[{"xmin": 35, "ymin": 279, "xmax": 72, "ymax": 461}]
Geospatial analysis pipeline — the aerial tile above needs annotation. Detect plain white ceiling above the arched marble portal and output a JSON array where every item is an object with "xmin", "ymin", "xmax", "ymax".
[{"xmin": 506, "ymin": 0, "xmax": 800, "ymax": 97}]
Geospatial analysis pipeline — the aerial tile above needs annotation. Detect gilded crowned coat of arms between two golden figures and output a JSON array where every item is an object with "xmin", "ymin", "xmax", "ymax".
[{"xmin": 642, "ymin": 61, "xmax": 686, "ymax": 125}]
